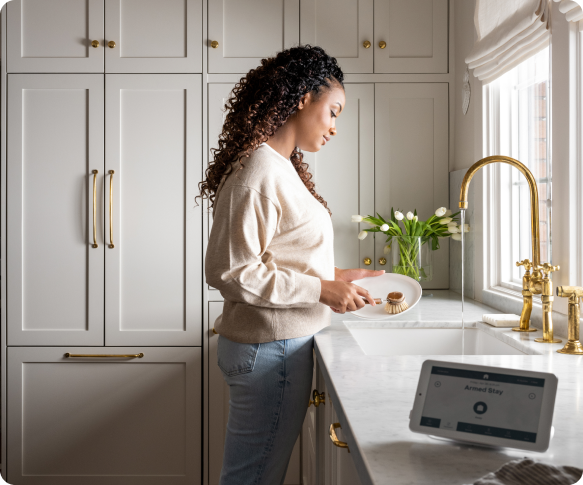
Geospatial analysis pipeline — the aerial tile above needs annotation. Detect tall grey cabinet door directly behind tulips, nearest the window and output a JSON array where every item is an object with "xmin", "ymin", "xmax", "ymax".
[{"xmin": 374, "ymin": 83, "xmax": 449, "ymax": 289}]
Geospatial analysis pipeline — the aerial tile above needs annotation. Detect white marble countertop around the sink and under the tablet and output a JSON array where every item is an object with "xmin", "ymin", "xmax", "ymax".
[{"xmin": 315, "ymin": 291, "xmax": 583, "ymax": 485}]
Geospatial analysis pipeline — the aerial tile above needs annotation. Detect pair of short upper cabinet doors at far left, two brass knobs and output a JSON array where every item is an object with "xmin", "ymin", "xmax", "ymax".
[{"xmin": 7, "ymin": 0, "xmax": 202, "ymax": 73}]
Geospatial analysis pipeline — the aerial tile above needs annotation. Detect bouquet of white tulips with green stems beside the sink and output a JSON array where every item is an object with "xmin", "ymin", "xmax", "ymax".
[{"xmin": 352, "ymin": 207, "xmax": 470, "ymax": 281}]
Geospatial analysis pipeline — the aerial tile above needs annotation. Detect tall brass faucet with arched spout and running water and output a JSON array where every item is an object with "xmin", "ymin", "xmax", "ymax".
[{"xmin": 459, "ymin": 155, "xmax": 560, "ymax": 343}]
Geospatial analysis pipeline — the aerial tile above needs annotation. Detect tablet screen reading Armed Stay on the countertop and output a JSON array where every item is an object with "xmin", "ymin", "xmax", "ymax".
[{"xmin": 421, "ymin": 366, "xmax": 545, "ymax": 443}]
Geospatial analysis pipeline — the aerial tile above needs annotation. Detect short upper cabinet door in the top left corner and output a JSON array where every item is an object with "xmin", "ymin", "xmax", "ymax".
[{"xmin": 6, "ymin": 0, "xmax": 103, "ymax": 72}]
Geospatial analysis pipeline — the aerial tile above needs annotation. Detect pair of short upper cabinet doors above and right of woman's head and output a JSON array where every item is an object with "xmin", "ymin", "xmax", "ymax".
[{"xmin": 300, "ymin": 0, "xmax": 449, "ymax": 74}]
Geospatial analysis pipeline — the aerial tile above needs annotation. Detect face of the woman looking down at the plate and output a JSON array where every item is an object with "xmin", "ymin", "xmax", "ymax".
[{"xmin": 296, "ymin": 83, "xmax": 346, "ymax": 152}]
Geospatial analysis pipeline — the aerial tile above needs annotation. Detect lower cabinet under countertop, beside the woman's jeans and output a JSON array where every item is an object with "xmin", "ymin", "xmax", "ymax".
[{"xmin": 302, "ymin": 356, "xmax": 361, "ymax": 485}]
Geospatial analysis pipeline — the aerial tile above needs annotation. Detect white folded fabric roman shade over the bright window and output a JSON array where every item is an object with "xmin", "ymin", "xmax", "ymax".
[{"xmin": 466, "ymin": 0, "xmax": 552, "ymax": 83}]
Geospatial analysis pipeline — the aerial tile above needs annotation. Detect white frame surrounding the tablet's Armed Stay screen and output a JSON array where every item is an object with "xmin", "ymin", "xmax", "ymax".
[{"xmin": 409, "ymin": 360, "xmax": 558, "ymax": 452}]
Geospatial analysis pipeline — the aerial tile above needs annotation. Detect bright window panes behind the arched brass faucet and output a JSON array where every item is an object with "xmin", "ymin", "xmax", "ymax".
[{"xmin": 484, "ymin": 47, "xmax": 552, "ymax": 291}]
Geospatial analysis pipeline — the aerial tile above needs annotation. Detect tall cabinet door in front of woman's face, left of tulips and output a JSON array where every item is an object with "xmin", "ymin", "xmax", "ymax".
[{"xmin": 304, "ymin": 84, "xmax": 375, "ymax": 268}]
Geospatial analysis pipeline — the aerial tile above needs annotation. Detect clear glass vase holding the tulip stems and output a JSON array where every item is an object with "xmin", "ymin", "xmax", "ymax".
[{"xmin": 389, "ymin": 236, "xmax": 433, "ymax": 282}]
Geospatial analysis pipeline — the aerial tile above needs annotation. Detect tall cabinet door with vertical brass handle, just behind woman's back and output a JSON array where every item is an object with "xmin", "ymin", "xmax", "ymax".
[{"xmin": 105, "ymin": 74, "xmax": 202, "ymax": 346}]
